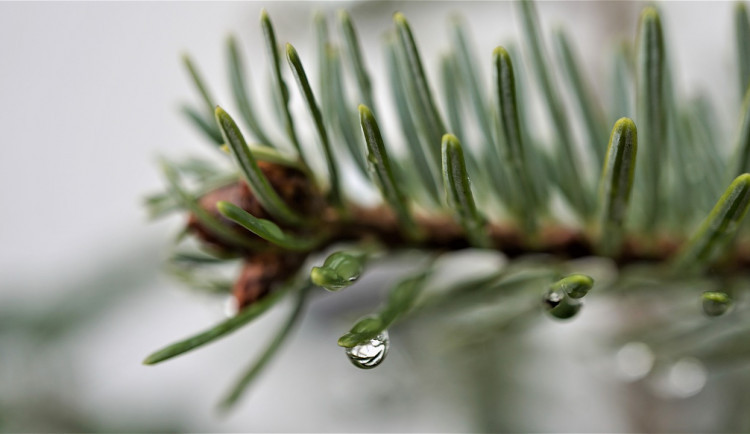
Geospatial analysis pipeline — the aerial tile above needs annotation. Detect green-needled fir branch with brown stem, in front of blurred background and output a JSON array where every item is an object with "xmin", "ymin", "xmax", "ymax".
[{"xmin": 144, "ymin": 1, "xmax": 750, "ymax": 406}]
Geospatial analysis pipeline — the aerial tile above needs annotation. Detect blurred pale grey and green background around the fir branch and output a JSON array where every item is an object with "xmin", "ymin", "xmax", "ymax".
[{"xmin": 0, "ymin": 1, "xmax": 750, "ymax": 432}]
